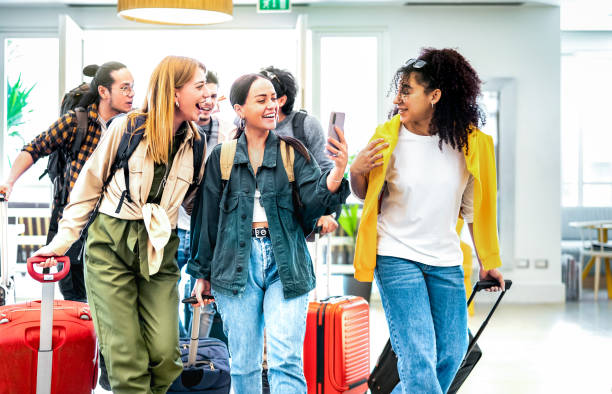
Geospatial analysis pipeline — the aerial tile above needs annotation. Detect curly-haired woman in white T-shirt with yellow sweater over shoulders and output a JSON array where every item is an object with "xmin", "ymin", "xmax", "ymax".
[{"xmin": 350, "ymin": 48, "xmax": 504, "ymax": 394}]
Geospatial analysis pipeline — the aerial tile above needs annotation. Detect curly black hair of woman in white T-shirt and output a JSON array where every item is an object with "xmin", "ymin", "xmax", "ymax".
[{"xmin": 391, "ymin": 48, "xmax": 485, "ymax": 151}]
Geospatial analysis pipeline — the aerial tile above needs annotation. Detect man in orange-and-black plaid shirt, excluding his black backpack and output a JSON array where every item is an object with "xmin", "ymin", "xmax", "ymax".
[{"xmin": 0, "ymin": 62, "xmax": 134, "ymax": 302}]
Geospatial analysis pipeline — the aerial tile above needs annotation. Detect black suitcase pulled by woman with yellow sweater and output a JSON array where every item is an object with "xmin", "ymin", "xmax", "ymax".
[{"xmin": 368, "ymin": 280, "xmax": 512, "ymax": 394}]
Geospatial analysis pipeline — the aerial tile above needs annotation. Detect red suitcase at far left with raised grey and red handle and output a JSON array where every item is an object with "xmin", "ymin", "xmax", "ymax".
[{"xmin": 0, "ymin": 258, "xmax": 98, "ymax": 394}]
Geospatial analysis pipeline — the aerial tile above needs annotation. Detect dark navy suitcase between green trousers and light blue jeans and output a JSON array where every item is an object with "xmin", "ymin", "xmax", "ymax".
[{"xmin": 168, "ymin": 298, "xmax": 231, "ymax": 394}]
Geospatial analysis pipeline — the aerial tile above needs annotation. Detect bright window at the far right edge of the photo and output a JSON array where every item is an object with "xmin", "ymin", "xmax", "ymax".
[{"xmin": 561, "ymin": 51, "xmax": 612, "ymax": 207}]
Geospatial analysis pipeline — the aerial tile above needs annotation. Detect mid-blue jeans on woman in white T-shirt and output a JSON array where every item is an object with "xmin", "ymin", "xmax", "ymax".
[{"xmin": 375, "ymin": 255, "xmax": 468, "ymax": 394}]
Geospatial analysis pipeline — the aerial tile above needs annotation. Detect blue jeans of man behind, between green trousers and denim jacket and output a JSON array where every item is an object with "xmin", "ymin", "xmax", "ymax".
[{"xmin": 176, "ymin": 228, "xmax": 215, "ymax": 338}]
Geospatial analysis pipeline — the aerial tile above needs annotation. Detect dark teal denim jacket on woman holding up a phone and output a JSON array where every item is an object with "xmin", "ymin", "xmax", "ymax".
[{"xmin": 187, "ymin": 132, "xmax": 350, "ymax": 298}]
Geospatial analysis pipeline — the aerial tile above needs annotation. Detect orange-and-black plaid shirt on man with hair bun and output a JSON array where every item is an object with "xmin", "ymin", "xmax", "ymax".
[{"xmin": 22, "ymin": 103, "xmax": 102, "ymax": 212}]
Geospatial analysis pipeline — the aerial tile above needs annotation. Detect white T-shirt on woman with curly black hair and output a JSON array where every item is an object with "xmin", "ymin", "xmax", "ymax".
[{"xmin": 377, "ymin": 125, "xmax": 474, "ymax": 266}]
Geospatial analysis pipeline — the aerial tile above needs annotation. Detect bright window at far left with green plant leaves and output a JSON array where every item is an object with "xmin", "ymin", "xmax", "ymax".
[{"xmin": 2, "ymin": 38, "xmax": 59, "ymax": 203}]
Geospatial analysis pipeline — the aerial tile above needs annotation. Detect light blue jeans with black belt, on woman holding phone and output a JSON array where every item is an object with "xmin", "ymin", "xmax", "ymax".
[{"xmin": 213, "ymin": 238, "xmax": 308, "ymax": 394}]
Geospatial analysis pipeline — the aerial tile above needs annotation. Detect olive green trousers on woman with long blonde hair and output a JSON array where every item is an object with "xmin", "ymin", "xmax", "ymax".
[{"xmin": 85, "ymin": 215, "xmax": 183, "ymax": 394}]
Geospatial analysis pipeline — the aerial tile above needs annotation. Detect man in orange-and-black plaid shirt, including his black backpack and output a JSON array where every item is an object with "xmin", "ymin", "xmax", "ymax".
[{"xmin": 0, "ymin": 62, "xmax": 134, "ymax": 302}]
